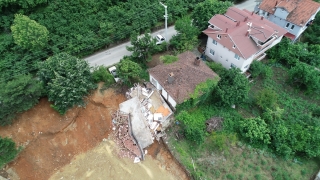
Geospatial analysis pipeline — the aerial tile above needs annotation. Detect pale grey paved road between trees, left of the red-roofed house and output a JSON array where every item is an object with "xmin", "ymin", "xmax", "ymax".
[{"xmin": 84, "ymin": 26, "xmax": 177, "ymax": 66}]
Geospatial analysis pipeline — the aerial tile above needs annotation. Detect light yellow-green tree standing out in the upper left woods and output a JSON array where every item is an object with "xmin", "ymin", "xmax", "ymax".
[{"xmin": 11, "ymin": 14, "xmax": 49, "ymax": 49}]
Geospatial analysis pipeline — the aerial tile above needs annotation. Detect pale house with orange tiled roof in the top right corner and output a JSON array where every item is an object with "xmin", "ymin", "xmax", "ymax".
[{"xmin": 255, "ymin": 0, "xmax": 320, "ymax": 41}]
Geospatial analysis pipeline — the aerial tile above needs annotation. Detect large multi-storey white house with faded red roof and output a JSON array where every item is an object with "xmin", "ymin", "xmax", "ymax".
[{"xmin": 203, "ymin": 7, "xmax": 287, "ymax": 72}]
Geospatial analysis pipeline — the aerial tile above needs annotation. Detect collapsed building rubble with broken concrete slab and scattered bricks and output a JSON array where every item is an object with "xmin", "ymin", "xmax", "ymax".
[{"xmin": 112, "ymin": 83, "xmax": 173, "ymax": 162}]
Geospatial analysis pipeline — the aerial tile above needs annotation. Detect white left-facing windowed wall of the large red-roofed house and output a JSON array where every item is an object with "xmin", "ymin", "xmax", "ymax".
[{"xmin": 206, "ymin": 37, "xmax": 252, "ymax": 72}]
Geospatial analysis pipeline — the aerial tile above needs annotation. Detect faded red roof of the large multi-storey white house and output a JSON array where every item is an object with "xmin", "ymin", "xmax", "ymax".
[{"xmin": 203, "ymin": 7, "xmax": 287, "ymax": 59}]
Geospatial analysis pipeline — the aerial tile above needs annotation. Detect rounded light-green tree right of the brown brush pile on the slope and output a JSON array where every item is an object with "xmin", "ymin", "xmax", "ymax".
[{"xmin": 239, "ymin": 117, "xmax": 271, "ymax": 145}]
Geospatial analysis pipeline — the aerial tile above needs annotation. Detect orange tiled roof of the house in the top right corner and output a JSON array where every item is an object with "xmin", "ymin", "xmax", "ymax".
[{"xmin": 259, "ymin": 0, "xmax": 320, "ymax": 26}]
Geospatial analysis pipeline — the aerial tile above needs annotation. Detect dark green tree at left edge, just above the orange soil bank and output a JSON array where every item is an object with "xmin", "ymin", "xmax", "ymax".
[{"xmin": 0, "ymin": 75, "xmax": 43, "ymax": 126}]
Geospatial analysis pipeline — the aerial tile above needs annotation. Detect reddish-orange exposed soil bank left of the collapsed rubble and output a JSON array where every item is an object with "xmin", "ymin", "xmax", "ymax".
[{"xmin": 0, "ymin": 84, "xmax": 189, "ymax": 180}]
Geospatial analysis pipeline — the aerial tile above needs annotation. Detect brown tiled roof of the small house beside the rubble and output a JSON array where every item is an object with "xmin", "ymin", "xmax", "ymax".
[{"xmin": 149, "ymin": 51, "xmax": 219, "ymax": 103}]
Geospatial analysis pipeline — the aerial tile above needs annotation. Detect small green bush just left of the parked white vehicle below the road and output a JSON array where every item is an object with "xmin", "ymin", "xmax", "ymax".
[{"xmin": 92, "ymin": 66, "xmax": 114, "ymax": 86}]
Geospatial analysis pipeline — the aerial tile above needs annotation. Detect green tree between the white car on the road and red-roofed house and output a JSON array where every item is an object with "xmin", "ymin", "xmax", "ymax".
[{"xmin": 170, "ymin": 16, "xmax": 200, "ymax": 52}]
